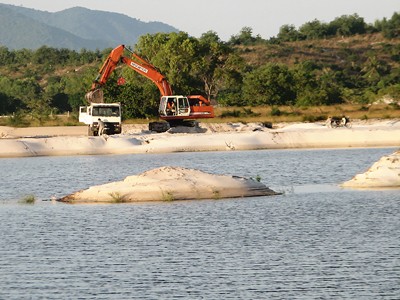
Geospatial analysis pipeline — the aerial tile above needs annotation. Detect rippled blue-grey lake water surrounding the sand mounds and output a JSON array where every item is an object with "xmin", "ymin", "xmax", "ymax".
[{"xmin": 0, "ymin": 148, "xmax": 400, "ymax": 299}]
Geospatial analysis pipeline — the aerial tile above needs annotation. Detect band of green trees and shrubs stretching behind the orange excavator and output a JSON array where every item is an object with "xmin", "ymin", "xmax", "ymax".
[{"xmin": 0, "ymin": 13, "xmax": 400, "ymax": 120}]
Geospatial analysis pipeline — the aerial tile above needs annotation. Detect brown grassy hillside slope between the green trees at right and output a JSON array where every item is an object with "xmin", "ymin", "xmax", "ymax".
[{"xmin": 238, "ymin": 33, "xmax": 400, "ymax": 69}]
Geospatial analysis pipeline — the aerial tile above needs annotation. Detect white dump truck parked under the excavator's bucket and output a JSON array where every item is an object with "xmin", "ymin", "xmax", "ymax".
[{"xmin": 79, "ymin": 103, "xmax": 122, "ymax": 136}]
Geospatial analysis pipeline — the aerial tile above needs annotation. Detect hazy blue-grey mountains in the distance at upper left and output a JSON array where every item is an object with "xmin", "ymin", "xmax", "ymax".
[{"xmin": 0, "ymin": 3, "xmax": 177, "ymax": 50}]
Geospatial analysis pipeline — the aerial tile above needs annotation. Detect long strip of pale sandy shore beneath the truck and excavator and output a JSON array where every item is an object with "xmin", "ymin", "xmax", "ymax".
[{"xmin": 0, "ymin": 119, "xmax": 400, "ymax": 157}]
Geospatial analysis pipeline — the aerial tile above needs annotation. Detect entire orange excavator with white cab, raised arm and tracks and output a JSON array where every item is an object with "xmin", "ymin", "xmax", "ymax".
[{"xmin": 85, "ymin": 45, "xmax": 214, "ymax": 132}]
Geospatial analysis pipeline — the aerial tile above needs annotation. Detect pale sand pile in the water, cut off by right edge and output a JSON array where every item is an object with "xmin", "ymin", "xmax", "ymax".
[{"xmin": 342, "ymin": 151, "xmax": 400, "ymax": 188}]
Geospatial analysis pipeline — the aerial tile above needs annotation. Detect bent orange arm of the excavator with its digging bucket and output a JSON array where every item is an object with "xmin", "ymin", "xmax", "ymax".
[{"xmin": 85, "ymin": 45, "xmax": 172, "ymax": 103}]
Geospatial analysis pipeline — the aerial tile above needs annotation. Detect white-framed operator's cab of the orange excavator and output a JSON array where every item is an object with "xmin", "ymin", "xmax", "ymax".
[{"xmin": 158, "ymin": 96, "xmax": 190, "ymax": 120}]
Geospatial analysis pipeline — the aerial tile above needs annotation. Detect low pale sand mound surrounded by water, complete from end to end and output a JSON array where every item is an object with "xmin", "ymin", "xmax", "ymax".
[{"xmin": 59, "ymin": 167, "xmax": 277, "ymax": 203}]
